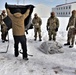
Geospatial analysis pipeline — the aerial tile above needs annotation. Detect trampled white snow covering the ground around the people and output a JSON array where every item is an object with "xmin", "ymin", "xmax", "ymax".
[{"xmin": 0, "ymin": 17, "xmax": 76, "ymax": 75}]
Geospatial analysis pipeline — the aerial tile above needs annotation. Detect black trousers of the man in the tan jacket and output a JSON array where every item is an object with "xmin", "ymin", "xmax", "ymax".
[{"xmin": 13, "ymin": 35, "xmax": 27, "ymax": 58}]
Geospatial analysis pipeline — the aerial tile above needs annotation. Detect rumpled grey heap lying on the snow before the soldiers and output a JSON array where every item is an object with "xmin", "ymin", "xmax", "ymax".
[{"xmin": 39, "ymin": 41, "xmax": 63, "ymax": 54}]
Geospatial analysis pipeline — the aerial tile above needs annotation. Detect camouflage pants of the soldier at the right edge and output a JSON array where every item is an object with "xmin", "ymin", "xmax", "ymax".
[{"xmin": 67, "ymin": 28, "xmax": 75, "ymax": 45}]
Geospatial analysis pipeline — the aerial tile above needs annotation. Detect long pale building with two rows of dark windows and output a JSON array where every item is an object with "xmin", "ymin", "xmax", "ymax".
[{"xmin": 52, "ymin": 2, "xmax": 76, "ymax": 17}]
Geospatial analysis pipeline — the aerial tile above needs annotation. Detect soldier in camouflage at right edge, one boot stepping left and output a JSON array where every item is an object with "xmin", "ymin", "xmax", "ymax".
[{"xmin": 64, "ymin": 10, "xmax": 76, "ymax": 48}]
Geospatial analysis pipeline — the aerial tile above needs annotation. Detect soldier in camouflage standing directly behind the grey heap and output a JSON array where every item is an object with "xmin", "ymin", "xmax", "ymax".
[{"xmin": 46, "ymin": 12, "xmax": 59, "ymax": 41}]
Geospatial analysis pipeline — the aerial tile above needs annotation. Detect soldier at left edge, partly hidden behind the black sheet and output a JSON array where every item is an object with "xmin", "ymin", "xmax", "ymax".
[{"xmin": 0, "ymin": 10, "xmax": 8, "ymax": 43}]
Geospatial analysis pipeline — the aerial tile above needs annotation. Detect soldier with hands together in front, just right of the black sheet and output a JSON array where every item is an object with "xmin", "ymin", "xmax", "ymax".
[{"xmin": 32, "ymin": 13, "xmax": 42, "ymax": 41}]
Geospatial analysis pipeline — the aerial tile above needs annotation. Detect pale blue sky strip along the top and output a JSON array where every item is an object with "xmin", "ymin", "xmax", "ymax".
[{"xmin": 0, "ymin": 0, "xmax": 76, "ymax": 9}]
